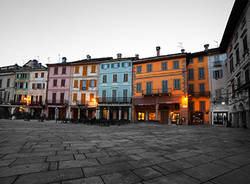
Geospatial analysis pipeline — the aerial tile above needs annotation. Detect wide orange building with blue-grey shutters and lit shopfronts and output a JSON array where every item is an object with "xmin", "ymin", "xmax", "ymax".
[{"xmin": 132, "ymin": 47, "xmax": 188, "ymax": 124}]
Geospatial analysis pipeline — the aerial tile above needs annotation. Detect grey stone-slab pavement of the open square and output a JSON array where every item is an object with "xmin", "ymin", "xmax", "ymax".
[{"xmin": 0, "ymin": 120, "xmax": 250, "ymax": 184}]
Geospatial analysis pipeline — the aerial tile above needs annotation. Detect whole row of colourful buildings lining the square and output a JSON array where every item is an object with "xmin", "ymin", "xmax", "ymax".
[{"xmin": 0, "ymin": 0, "xmax": 250, "ymax": 127}]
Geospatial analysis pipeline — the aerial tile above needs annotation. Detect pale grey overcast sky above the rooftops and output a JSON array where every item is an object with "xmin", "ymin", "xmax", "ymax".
[{"xmin": 0, "ymin": 0, "xmax": 234, "ymax": 66}]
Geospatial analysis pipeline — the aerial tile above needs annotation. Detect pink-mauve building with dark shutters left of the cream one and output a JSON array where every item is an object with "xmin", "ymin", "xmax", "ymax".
[{"xmin": 46, "ymin": 57, "xmax": 71, "ymax": 119}]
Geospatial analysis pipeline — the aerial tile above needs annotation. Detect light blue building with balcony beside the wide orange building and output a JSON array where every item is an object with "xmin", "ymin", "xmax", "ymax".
[{"xmin": 98, "ymin": 54, "xmax": 136, "ymax": 120}]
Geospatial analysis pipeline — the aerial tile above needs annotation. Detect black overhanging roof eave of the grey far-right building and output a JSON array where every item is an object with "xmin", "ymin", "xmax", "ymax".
[{"xmin": 220, "ymin": 0, "xmax": 249, "ymax": 52}]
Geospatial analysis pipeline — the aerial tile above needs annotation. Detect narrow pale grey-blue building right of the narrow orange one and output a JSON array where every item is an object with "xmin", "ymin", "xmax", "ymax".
[{"xmin": 208, "ymin": 49, "xmax": 228, "ymax": 125}]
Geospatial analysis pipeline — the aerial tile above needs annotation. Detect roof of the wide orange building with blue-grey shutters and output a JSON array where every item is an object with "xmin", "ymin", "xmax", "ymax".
[{"xmin": 133, "ymin": 53, "xmax": 187, "ymax": 64}]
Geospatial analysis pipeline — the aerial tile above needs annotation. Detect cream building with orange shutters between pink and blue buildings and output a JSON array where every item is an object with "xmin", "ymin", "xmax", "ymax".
[{"xmin": 69, "ymin": 55, "xmax": 112, "ymax": 119}]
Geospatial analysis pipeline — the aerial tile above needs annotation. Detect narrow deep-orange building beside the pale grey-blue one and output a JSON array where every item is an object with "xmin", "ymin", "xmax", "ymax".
[{"xmin": 187, "ymin": 44, "xmax": 213, "ymax": 124}]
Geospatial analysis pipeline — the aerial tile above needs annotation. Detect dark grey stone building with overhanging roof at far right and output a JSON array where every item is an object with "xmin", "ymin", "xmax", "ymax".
[{"xmin": 220, "ymin": 0, "xmax": 250, "ymax": 128}]
